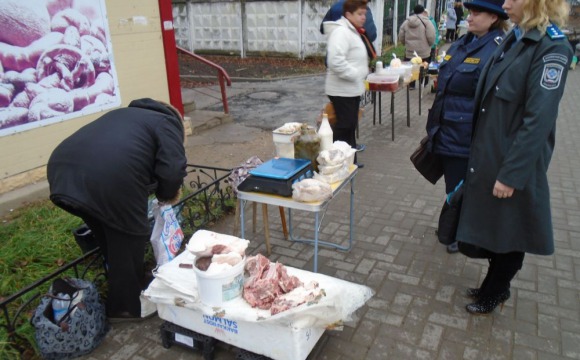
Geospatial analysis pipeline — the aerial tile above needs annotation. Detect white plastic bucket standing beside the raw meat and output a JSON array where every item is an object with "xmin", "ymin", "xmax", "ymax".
[{"xmin": 193, "ymin": 257, "xmax": 246, "ymax": 306}]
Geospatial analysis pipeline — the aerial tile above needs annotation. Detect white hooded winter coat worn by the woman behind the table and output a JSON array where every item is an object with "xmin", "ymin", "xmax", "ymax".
[{"xmin": 324, "ymin": 17, "xmax": 369, "ymax": 97}]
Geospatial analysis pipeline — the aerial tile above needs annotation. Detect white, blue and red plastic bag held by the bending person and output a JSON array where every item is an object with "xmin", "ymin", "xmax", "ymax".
[{"xmin": 151, "ymin": 200, "xmax": 183, "ymax": 265}]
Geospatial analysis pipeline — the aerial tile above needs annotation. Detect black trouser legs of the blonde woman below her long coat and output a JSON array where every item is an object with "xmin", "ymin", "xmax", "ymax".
[{"xmin": 480, "ymin": 252, "xmax": 525, "ymax": 298}]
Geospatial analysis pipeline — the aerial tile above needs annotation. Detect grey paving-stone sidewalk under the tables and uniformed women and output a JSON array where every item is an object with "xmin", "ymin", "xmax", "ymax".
[{"xmin": 85, "ymin": 70, "xmax": 580, "ymax": 360}]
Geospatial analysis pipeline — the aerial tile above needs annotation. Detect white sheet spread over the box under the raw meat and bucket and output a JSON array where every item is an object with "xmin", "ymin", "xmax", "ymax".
[{"xmin": 145, "ymin": 252, "xmax": 374, "ymax": 329}]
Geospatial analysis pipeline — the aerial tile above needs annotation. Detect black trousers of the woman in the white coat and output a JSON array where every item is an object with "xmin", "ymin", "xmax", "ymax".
[{"xmin": 328, "ymin": 95, "xmax": 360, "ymax": 163}]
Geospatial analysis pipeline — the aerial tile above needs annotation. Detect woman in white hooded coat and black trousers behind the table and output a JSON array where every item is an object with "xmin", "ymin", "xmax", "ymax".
[{"xmin": 324, "ymin": 0, "xmax": 369, "ymax": 167}]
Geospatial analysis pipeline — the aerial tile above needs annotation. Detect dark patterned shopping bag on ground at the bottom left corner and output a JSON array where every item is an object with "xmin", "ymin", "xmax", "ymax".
[{"xmin": 30, "ymin": 278, "xmax": 109, "ymax": 360}]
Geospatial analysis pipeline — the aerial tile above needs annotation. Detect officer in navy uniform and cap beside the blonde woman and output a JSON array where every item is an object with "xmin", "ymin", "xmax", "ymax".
[{"xmin": 427, "ymin": 0, "xmax": 508, "ymax": 253}]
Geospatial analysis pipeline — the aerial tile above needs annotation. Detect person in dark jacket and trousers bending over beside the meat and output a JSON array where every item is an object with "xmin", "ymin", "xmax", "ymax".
[{"xmin": 47, "ymin": 99, "xmax": 186, "ymax": 319}]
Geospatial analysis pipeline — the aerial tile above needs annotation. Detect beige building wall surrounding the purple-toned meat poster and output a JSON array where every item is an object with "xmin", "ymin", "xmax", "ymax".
[{"xmin": 0, "ymin": 0, "xmax": 169, "ymax": 194}]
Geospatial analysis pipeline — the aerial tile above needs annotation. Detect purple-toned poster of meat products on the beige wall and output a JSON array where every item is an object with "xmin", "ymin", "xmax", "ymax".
[{"xmin": 0, "ymin": 0, "xmax": 121, "ymax": 136}]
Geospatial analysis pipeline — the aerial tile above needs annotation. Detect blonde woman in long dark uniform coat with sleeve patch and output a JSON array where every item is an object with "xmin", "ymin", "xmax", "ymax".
[{"xmin": 456, "ymin": 0, "xmax": 573, "ymax": 314}]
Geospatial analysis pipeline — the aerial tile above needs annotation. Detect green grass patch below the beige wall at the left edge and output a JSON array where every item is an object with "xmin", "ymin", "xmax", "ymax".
[{"xmin": 0, "ymin": 200, "xmax": 82, "ymax": 359}]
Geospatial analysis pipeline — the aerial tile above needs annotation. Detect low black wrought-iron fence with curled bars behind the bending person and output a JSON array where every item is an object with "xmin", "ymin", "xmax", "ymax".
[{"xmin": 0, "ymin": 164, "xmax": 235, "ymax": 353}]
